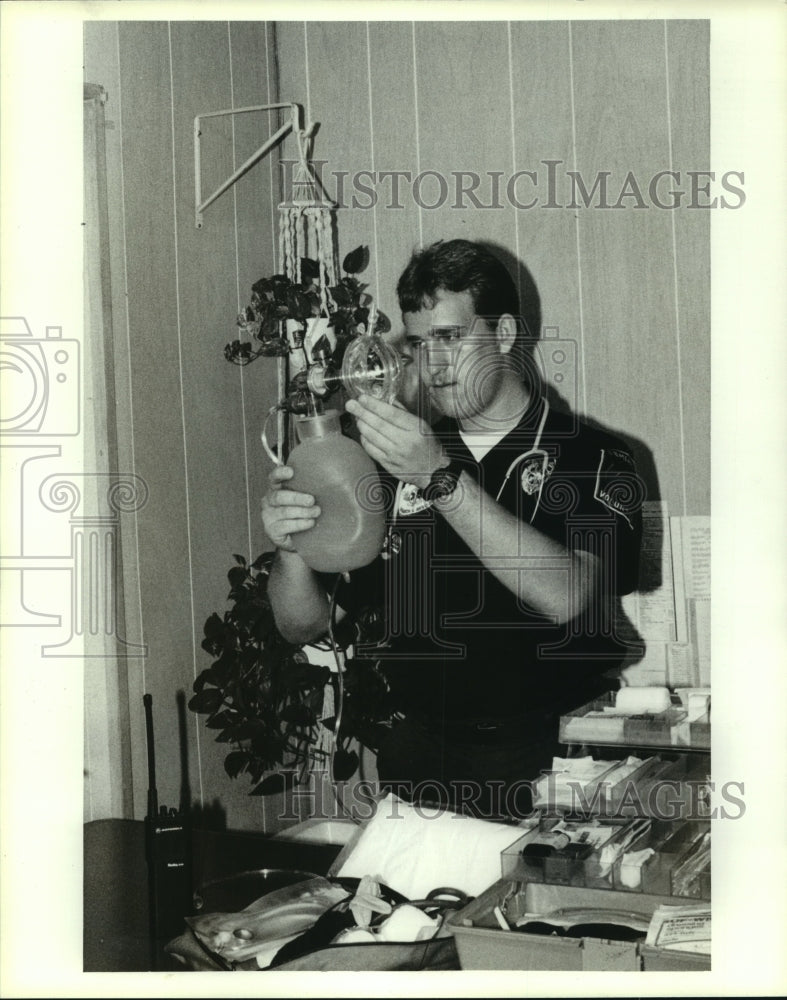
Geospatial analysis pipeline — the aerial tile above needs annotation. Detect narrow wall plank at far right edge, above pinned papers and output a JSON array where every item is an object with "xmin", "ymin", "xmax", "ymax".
[{"xmin": 665, "ymin": 21, "xmax": 712, "ymax": 514}]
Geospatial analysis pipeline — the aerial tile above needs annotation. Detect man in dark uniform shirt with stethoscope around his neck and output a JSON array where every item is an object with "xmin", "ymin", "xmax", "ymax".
[{"xmin": 263, "ymin": 240, "xmax": 642, "ymax": 816}]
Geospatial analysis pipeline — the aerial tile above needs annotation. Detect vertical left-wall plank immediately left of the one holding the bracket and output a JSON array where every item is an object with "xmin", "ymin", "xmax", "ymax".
[{"xmin": 119, "ymin": 22, "xmax": 193, "ymax": 810}]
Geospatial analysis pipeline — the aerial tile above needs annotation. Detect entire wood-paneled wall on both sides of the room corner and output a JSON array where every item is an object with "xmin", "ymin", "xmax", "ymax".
[{"xmin": 85, "ymin": 20, "xmax": 711, "ymax": 827}]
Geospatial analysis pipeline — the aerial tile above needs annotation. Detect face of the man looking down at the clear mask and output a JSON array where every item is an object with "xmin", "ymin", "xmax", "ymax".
[{"xmin": 403, "ymin": 290, "xmax": 503, "ymax": 422}]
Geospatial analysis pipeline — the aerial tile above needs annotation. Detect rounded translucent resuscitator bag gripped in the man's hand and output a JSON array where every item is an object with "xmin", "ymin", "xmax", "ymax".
[{"xmin": 287, "ymin": 410, "xmax": 385, "ymax": 573}]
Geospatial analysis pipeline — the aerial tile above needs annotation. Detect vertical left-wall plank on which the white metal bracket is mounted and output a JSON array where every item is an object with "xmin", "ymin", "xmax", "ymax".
[{"xmin": 171, "ymin": 22, "xmax": 274, "ymax": 823}]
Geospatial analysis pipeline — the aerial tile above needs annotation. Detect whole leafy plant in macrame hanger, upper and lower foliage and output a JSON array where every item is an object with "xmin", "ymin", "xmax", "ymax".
[{"xmin": 202, "ymin": 158, "xmax": 391, "ymax": 795}]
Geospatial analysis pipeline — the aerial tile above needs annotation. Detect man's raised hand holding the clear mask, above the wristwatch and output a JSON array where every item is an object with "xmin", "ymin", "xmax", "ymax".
[{"xmin": 346, "ymin": 396, "xmax": 449, "ymax": 489}]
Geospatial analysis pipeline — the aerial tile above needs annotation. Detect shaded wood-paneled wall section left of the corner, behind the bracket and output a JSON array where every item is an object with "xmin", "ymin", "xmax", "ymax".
[{"xmin": 85, "ymin": 22, "xmax": 278, "ymax": 828}]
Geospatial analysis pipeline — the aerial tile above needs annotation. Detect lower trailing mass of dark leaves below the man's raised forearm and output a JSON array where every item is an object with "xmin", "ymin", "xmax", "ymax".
[{"xmin": 189, "ymin": 552, "xmax": 392, "ymax": 795}]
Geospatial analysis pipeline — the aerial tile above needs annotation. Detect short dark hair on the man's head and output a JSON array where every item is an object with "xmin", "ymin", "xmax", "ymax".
[{"xmin": 396, "ymin": 240, "xmax": 519, "ymax": 326}]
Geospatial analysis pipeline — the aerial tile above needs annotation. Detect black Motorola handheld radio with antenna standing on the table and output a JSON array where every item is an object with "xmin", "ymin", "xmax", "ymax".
[{"xmin": 143, "ymin": 694, "xmax": 193, "ymax": 969}]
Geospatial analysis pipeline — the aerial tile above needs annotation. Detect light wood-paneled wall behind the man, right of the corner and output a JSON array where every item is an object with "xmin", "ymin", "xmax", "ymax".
[{"xmin": 278, "ymin": 21, "xmax": 710, "ymax": 514}]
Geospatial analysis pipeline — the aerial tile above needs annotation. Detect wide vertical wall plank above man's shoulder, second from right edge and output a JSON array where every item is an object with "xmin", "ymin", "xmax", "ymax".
[{"xmin": 572, "ymin": 21, "xmax": 683, "ymax": 512}]
